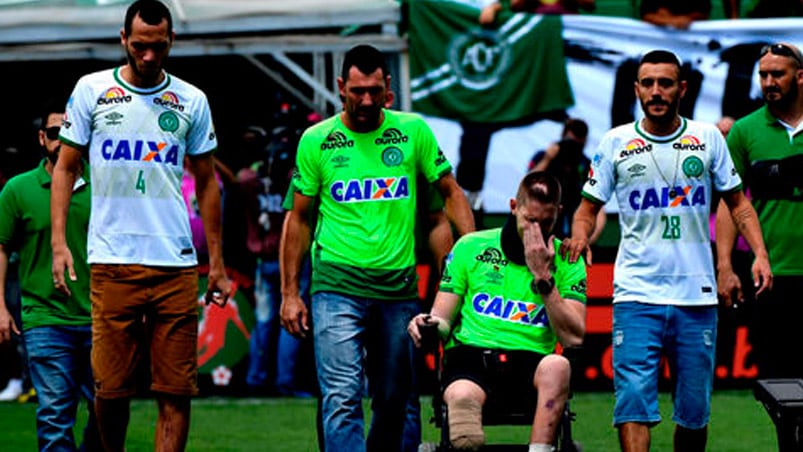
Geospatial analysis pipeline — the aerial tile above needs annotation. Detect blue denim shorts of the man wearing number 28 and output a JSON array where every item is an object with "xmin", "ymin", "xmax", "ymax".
[{"xmin": 613, "ymin": 302, "xmax": 717, "ymax": 429}]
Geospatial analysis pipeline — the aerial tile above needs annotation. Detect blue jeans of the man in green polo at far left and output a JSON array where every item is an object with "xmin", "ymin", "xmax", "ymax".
[{"xmin": 23, "ymin": 325, "xmax": 101, "ymax": 451}]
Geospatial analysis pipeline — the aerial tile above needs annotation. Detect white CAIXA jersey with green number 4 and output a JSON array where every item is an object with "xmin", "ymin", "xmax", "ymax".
[{"xmin": 61, "ymin": 68, "xmax": 217, "ymax": 266}]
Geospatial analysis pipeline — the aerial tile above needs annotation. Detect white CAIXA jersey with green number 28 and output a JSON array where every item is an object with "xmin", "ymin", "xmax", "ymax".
[{"xmin": 583, "ymin": 118, "xmax": 741, "ymax": 305}]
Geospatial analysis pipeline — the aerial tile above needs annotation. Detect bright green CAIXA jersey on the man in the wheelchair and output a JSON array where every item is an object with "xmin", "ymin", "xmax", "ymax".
[{"xmin": 440, "ymin": 228, "xmax": 586, "ymax": 354}]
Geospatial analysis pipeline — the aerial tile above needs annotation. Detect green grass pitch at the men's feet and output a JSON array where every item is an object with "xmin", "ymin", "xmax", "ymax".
[{"xmin": 0, "ymin": 391, "xmax": 777, "ymax": 452}]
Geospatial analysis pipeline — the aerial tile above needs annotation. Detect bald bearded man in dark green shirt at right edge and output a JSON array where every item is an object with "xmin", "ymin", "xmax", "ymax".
[{"xmin": 716, "ymin": 43, "xmax": 803, "ymax": 378}]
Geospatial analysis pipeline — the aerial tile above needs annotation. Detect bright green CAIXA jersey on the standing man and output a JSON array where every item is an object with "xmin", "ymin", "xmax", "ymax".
[{"xmin": 293, "ymin": 110, "xmax": 452, "ymax": 299}]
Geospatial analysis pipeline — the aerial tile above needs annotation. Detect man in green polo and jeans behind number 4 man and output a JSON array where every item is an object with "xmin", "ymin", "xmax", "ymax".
[{"xmin": 0, "ymin": 102, "xmax": 100, "ymax": 451}]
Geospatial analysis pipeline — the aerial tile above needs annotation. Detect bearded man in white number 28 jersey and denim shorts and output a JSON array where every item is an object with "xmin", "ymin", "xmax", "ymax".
[{"xmin": 560, "ymin": 50, "xmax": 772, "ymax": 451}]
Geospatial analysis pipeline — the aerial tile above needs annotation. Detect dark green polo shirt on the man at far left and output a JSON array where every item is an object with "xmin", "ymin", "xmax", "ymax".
[{"xmin": 0, "ymin": 160, "xmax": 92, "ymax": 330}]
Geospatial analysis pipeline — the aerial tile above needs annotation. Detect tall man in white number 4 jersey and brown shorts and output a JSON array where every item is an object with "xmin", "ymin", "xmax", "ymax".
[{"xmin": 51, "ymin": 0, "xmax": 230, "ymax": 451}]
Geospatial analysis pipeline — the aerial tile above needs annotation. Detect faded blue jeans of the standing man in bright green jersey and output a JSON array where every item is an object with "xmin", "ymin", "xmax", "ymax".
[{"xmin": 312, "ymin": 292, "xmax": 419, "ymax": 452}]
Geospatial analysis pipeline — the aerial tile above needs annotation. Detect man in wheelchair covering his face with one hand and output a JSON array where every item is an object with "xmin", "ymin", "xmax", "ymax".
[{"xmin": 408, "ymin": 172, "xmax": 586, "ymax": 452}]
